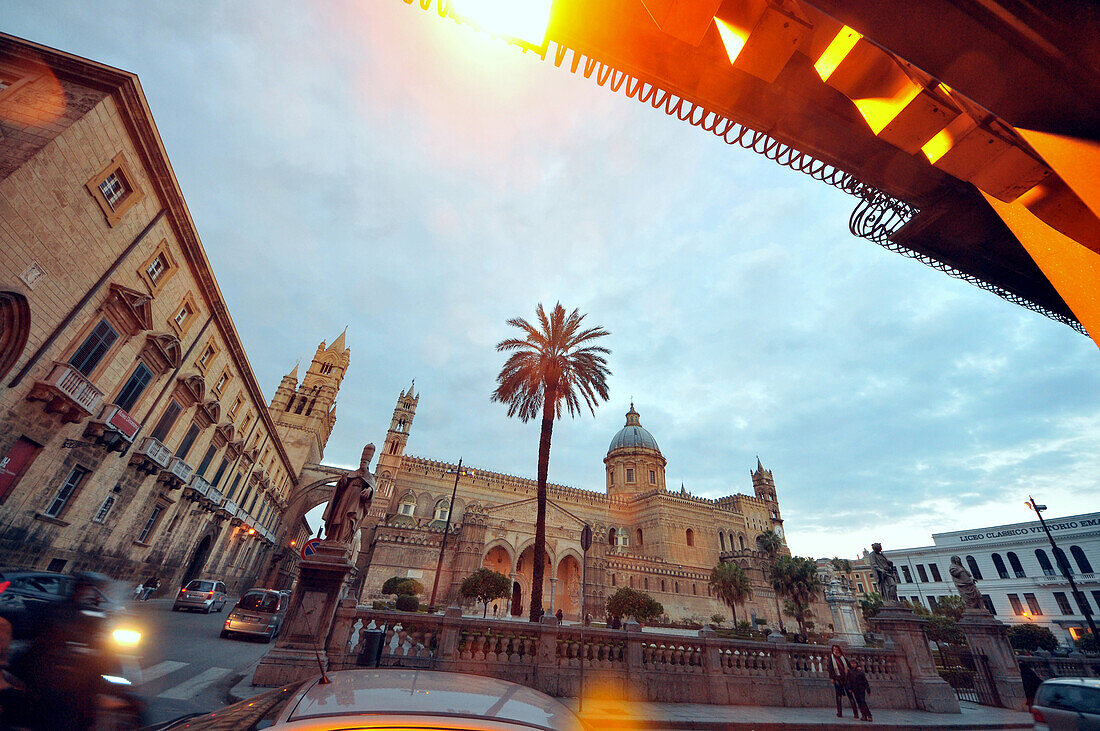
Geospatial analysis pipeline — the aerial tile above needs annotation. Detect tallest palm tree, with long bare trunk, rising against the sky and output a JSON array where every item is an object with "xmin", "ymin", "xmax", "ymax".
[{"xmin": 492, "ymin": 302, "xmax": 611, "ymax": 622}]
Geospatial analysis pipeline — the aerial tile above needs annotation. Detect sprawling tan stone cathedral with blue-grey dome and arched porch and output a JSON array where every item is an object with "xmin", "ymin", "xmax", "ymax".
[{"xmin": 360, "ymin": 387, "xmax": 828, "ymax": 628}]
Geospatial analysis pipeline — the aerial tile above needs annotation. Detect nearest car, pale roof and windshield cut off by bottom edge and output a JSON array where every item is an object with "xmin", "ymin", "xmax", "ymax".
[{"xmin": 160, "ymin": 668, "xmax": 584, "ymax": 731}]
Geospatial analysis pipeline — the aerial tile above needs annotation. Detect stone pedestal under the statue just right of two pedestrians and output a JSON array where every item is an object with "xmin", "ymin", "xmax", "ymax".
[{"xmin": 871, "ymin": 607, "xmax": 961, "ymax": 713}]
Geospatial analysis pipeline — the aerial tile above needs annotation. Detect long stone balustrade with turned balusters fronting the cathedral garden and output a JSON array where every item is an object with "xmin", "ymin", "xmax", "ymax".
[{"xmin": 326, "ymin": 600, "xmax": 917, "ymax": 708}]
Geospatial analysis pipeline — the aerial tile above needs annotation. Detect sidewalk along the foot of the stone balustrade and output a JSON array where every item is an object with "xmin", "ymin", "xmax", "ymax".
[{"xmin": 229, "ymin": 661, "xmax": 1034, "ymax": 731}]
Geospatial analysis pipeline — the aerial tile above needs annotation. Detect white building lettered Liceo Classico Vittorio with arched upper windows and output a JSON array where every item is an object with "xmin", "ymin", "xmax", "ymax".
[{"xmin": 886, "ymin": 512, "xmax": 1100, "ymax": 644}]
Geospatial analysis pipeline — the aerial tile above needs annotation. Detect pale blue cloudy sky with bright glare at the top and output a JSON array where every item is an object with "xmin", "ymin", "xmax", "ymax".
[{"xmin": 10, "ymin": 0, "xmax": 1100, "ymax": 557}]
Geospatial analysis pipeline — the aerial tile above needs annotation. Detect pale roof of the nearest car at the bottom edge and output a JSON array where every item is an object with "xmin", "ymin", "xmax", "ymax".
[{"xmin": 286, "ymin": 668, "xmax": 582, "ymax": 731}]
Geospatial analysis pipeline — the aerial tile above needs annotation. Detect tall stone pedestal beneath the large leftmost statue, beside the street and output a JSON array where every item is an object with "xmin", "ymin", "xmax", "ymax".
[{"xmin": 252, "ymin": 541, "xmax": 354, "ymax": 687}]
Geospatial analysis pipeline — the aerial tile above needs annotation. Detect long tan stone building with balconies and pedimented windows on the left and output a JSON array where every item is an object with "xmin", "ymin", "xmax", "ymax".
[{"xmin": 0, "ymin": 35, "xmax": 303, "ymax": 591}]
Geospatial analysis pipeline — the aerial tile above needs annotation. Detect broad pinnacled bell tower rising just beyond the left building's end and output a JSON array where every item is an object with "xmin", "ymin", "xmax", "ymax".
[{"xmin": 267, "ymin": 328, "xmax": 351, "ymax": 474}]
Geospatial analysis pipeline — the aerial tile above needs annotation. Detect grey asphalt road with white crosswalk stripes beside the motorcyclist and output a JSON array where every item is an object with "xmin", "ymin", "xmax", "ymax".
[{"xmin": 132, "ymin": 597, "xmax": 274, "ymax": 723}]
